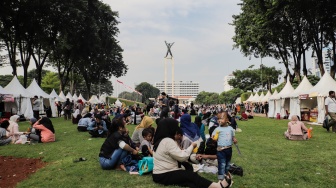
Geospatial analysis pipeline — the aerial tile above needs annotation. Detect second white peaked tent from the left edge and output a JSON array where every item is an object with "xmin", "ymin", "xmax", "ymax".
[{"xmin": 27, "ymin": 79, "xmax": 57, "ymax": 117}]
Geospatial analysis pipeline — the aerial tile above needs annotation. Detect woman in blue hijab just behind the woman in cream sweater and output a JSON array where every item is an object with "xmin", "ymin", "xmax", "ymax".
[{"xmin": 180, "ymin": 114, "xmax": 200, "ymax": 142}]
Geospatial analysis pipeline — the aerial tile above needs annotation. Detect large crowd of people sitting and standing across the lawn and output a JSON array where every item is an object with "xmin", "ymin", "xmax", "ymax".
[{"xmin": 0, "ymin": 90, "xmax": 316, "ymax": 187}]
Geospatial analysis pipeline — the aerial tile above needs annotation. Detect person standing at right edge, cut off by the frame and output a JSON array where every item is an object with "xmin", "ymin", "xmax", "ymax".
[{"xmin": 324, "ymin": 91, "xmax": 336, "ymax": 132}]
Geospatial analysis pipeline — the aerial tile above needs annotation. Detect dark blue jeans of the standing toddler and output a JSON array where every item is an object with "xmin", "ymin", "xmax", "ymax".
[{"xmin": 217, "ymin": 148, "xmax": 232, "ymax": 180}]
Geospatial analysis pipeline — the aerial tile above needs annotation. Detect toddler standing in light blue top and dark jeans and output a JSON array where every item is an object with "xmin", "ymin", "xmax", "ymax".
[{"xmin": 212, "ymin": 112, "xmax": 237, "ymax": 180}]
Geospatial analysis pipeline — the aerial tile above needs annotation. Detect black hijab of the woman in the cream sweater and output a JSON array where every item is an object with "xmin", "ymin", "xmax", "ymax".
[{"xmin": 153, "ymin": 118, "xmax": 179, "ymax": 151}]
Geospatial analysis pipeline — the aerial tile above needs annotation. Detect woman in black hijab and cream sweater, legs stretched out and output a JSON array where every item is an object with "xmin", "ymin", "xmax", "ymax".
[{"xmin": 152, "ymin": 118, "xmax": 231, "ymax": 188}]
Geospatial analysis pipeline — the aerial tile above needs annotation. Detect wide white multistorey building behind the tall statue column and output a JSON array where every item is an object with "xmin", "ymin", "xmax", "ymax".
[{"xmin": 154, "ymin": 81, "xmax": 199, "ymax": 97}]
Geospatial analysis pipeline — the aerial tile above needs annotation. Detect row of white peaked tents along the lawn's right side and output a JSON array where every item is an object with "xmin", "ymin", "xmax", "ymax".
[{"xmin": 268, "ymin": 73, "xmax": 336, "ymax": 123}]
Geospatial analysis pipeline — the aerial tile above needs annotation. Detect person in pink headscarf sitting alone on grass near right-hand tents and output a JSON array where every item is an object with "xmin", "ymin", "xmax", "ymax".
[{"xmin": 285, "ymin": 116, "xmax": 308, "ymax": 140}]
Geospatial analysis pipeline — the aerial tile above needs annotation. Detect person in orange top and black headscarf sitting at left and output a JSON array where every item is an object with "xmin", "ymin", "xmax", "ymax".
[{"xmin": 28, "ymin": 117, "xmax": 55, "ymax": 143}]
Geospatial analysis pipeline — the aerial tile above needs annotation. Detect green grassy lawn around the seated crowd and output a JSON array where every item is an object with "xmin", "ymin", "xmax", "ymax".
[{"xmin": 0, "ymin": 117, "xmax": 336, "ymax": 187}]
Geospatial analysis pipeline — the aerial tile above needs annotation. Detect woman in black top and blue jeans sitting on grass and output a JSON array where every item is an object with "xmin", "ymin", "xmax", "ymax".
[{"xmin": 99, "ymin": 118, "xmax": 138, "ymax": 170}]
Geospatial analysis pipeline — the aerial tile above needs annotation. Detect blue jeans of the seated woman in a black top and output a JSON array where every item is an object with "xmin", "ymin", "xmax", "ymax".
[{"xmin": 99, "ymin": 148, "xmax": 127, "ymax": 170}]
